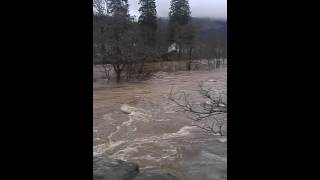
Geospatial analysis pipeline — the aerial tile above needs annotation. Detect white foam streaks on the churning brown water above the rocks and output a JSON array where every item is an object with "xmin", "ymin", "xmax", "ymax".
[{"xmin": 93, "ymin": 104, "xmax": 199, "ymax": 162}]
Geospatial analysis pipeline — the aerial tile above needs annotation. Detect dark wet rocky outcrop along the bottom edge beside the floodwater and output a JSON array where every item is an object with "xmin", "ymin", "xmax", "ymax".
[{"xmin": 93, "ymin": 156, "xmax": 179, "ymax": 180}]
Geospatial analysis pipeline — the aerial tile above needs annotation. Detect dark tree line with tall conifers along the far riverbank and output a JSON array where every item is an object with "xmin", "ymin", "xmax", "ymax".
[{"xmin": 93, "ymin": 0, "xmax": 227, "ymax": 80}]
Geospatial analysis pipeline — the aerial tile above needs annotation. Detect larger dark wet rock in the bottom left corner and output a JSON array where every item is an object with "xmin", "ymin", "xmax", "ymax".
[{"xmin": 93, "ymin": 156, "xmax": 139, "ymax": 180}]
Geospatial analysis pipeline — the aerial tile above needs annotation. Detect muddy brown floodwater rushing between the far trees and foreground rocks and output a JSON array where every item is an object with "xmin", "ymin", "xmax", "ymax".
[{"xmin": 93, "ymin": 68, "xmax": 227, "ymax": 180}]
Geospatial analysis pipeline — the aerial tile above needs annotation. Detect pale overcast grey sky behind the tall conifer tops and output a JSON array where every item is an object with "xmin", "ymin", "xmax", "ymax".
[{"xmin": 129, "ymin": 0, "xmax": 227, "ymax": 19}]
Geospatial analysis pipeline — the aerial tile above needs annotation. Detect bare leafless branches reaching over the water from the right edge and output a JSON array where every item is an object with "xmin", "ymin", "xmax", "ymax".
[{"xmin": 169, "ymin": 83, "xmax": 227, "ymax": 136}]
